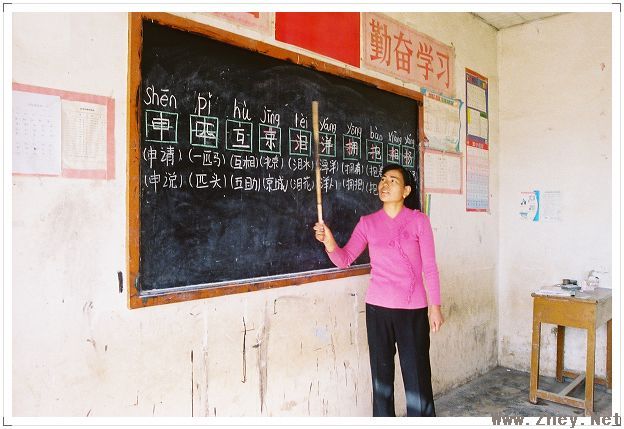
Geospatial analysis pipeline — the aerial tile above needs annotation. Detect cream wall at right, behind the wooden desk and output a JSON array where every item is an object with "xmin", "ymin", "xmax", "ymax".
[{"xmin": 498, "ymin": 13, "xmax": 617, "ymax": 375}]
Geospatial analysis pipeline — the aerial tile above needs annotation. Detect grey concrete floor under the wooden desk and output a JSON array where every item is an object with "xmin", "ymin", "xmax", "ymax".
[{"xmin": 435, "ymin": 367, "xmax": 611, "ymax": 417}]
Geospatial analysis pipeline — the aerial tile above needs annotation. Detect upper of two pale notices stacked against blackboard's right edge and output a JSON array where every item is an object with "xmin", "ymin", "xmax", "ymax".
[{"xmin": 421, "ymin": 89, "xmax": 461, "ymax": 152}]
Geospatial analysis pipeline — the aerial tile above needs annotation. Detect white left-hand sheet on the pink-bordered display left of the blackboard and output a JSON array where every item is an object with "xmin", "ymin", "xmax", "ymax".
[{"xmin": 13, "ymin": 91, "xmax": 61, "ymax": 175}]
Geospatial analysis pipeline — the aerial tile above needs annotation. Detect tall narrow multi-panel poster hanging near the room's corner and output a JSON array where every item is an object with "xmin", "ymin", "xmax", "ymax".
[{"xmin": 465, "ymin": 69, "xmax": 490, "ymax": 212}]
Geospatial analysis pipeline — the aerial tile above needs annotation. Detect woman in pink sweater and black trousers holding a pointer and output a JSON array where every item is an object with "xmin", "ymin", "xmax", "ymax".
[{"xmin": 314, "ymin": 164, "xmax": 444, "ymax": 417}]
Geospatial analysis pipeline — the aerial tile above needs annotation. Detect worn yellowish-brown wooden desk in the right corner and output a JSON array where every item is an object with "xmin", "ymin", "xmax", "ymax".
[{"xmin": 529, "ymin": 288, "xmax": 611, "ymax": 416}]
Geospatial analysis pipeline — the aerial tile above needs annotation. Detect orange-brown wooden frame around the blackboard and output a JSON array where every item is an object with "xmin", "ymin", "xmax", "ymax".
[{"xmin": 126, "ymin": 12, "xmax": 424, "ymax": 308}]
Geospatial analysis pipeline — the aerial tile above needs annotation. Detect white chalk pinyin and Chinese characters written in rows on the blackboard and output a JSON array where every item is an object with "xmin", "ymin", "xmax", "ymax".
[{"xmin": 141, "ymin": 85, "xmax": 417, "ymax": 195}]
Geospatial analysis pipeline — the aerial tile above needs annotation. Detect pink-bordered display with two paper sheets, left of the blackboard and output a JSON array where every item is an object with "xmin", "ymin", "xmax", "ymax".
[{"xmin": 13, "ymin": 82, "xmax": 115, "ymax": 179}]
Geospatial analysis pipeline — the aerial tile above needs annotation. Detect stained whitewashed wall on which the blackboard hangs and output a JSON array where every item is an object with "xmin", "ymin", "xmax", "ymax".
[{"xmin": 11, "ymin": 13, "xmax": 500, "ymax": 417}]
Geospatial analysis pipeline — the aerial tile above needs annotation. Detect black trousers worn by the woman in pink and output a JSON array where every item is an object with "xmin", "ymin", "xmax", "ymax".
[{"xmin": 366, "ymin": 304, "xmax": 435, "ymax": 417}]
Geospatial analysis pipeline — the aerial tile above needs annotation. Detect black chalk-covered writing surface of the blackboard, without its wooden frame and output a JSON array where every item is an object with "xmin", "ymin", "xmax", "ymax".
[{"xmin": 126, "ymin": 14, "xmax": 419, "ymax": 308}]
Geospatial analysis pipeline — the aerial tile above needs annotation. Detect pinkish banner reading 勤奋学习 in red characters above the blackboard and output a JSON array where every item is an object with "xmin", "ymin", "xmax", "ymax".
[{"xmin": 362, "ymin": 12, "xmax": 455, "ymax": 97}]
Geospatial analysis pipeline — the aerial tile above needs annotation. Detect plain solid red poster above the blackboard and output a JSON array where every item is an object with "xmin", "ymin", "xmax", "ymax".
[{"xmin": 275, "ymin": 12, "xmax": 360, "ymax": 67}]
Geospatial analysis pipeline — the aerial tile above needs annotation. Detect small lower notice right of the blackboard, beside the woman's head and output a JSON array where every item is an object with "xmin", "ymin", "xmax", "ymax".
[{"xmin": 424, "ymin": 149, "xmax": 462, "ymax": 194}]
